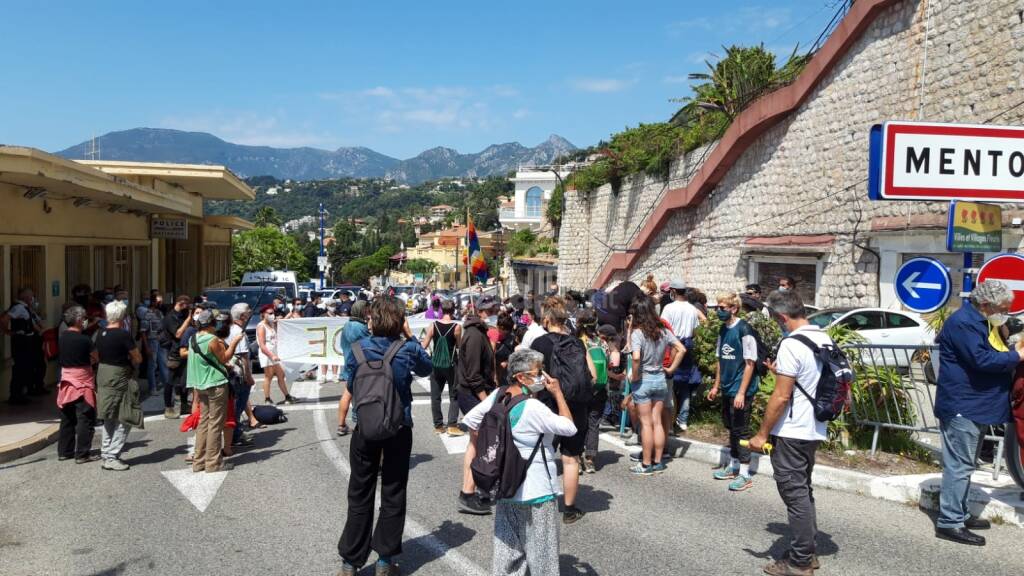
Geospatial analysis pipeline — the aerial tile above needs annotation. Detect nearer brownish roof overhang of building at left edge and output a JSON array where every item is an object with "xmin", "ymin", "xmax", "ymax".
[{"xmin": 0, "ymin": 146, "xmax": 203, "ymax": 216}]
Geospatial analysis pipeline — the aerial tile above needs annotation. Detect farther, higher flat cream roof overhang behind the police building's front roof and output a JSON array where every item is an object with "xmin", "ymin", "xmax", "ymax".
[{"xmin": 76, "ymin": 160, "xmax": 256, "ymax": 200}]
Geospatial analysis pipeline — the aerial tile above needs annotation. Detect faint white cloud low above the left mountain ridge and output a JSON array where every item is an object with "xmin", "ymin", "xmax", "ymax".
[{"xmin": 158, "ymin": 111, "xmax": 339, "ymax": 148}]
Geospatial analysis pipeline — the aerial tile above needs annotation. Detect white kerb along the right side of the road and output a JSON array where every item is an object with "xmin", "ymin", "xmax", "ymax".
[{"xmin": 601, "ymin": 433, "xmax": 1024, "ymax": 528}]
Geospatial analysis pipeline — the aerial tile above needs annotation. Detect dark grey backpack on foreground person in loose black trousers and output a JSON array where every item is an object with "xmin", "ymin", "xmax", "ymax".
[{"xmin": 352, "ymin": 339, "xmax": 406, "ymax": 442}]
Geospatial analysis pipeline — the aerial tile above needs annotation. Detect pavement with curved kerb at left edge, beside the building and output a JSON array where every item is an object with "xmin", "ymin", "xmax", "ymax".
[{"xmin": 0, "ymin": 392, "xmax": 60, "ymax": 463}]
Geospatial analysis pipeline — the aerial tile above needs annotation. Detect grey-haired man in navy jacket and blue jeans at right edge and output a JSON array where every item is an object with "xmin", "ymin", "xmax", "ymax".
[{"xmin": 935, "ymin": 280, "xmax": 1024, "ymax": 546}]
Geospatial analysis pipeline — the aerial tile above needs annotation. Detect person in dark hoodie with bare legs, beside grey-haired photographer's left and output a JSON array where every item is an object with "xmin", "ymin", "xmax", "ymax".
[{"xmin": 457, "ymin": 296, "xmax": 498, "ymax": 515}]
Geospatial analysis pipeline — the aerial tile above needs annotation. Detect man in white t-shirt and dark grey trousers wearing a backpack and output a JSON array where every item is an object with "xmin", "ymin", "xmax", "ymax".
[{"xmin": 750, "ymin": 291, "xmax": 831, "ymax": 576}]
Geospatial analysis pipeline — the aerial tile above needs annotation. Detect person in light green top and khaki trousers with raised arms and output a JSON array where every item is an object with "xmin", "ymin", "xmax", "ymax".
[{"xmin": 187, "ymin": 310, "xmax": 245, "ymax": 472}]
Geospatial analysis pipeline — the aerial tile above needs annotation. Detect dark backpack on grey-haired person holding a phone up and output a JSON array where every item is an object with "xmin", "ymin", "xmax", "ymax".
[{"xmin": 468, "ymin": 386, "xmax": 550, "ymax": 499}]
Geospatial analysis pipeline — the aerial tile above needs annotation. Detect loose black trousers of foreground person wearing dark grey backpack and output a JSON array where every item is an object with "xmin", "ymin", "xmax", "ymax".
[{"xmin": 338, "ymin": 424, "xmax": 413, "ymax": 568}]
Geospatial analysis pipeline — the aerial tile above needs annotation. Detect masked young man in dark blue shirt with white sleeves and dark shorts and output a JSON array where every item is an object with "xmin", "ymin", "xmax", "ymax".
[{"xmin": 708, "ymin": 292, "xmax": 759, "ymax": 492}]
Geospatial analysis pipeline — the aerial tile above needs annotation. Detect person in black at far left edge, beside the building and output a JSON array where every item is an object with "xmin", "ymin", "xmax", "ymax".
[{"xmin": 0, "ymin": 288, "xmax": 46, "ymax": 404}]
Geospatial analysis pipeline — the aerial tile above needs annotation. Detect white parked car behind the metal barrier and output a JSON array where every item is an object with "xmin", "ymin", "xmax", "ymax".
[{"xmin": 807, "ymin": 308, "xmax": 935, "ymax": 367}]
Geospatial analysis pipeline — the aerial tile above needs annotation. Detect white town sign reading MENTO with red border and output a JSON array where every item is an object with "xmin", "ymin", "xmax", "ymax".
[{"xmin": 869, "ymin": 122, "xmax": 1024, "ymax": 202}]
